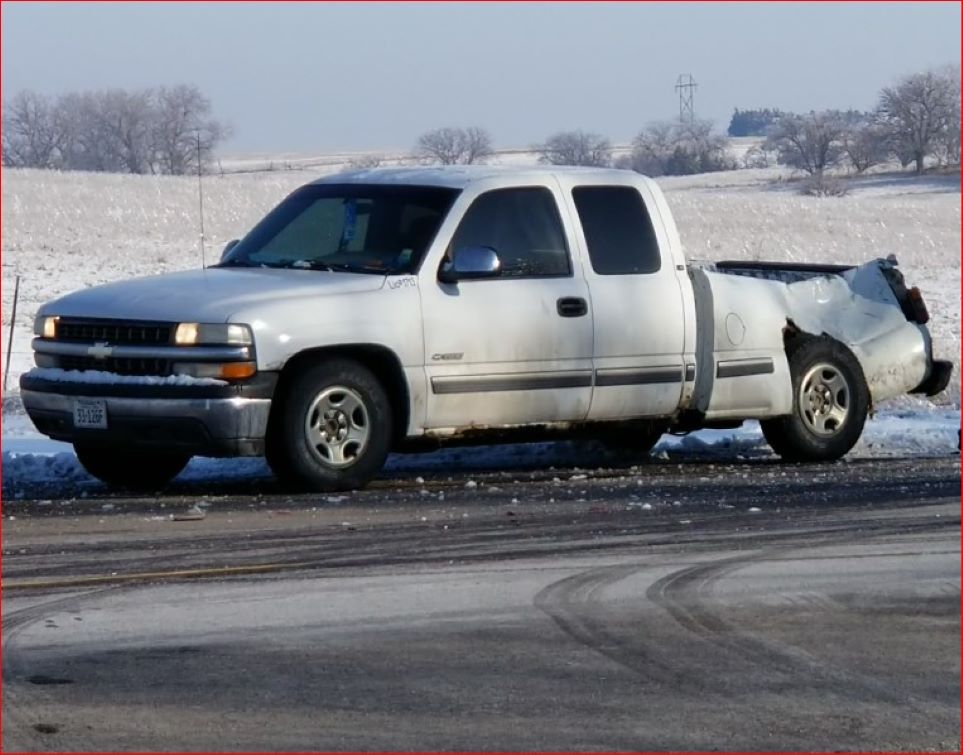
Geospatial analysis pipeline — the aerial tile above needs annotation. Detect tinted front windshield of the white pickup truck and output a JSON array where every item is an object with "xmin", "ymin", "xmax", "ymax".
[{"xmin": 220, "ymin": 184, "xmax": 458, "ymax": 275}]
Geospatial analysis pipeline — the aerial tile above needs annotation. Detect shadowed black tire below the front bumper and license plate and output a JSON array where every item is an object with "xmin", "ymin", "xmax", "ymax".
[{"xmin": 74, "ymin": 443, "xmax": 191, "ymax": 490}]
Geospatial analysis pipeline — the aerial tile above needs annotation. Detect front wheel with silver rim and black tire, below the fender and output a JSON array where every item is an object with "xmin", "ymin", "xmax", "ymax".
[{"xmin": 265, "ymin": 359, "xmax": 392, "ymax": 492}]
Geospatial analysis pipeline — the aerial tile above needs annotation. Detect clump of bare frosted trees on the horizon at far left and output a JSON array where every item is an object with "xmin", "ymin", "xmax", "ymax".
[{"xmin": 2, "ymin": 84, "xmax": 230, "ymax": 175}]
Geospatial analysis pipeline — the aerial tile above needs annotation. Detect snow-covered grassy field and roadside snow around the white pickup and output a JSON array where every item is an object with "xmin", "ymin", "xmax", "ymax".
[{"xmin": 0, "ymin": 157, "xmax": 960, "ymax": 495}]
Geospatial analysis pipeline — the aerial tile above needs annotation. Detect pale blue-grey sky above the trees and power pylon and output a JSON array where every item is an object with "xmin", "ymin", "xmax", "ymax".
[{"xmin": 2, "ymin": 2, "xmax": 960, "ymax": 152}]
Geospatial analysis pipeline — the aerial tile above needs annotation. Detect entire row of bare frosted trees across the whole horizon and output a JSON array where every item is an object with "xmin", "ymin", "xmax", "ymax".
[{"xmin": 2, "ymin": 65, "xmax": 960, "ymax": 177}]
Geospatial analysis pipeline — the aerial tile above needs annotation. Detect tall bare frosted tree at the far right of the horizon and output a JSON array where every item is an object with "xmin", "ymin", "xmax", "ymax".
[{"xmin": 879, "ymin": 67, "xmax": 960, "ymax": 173}]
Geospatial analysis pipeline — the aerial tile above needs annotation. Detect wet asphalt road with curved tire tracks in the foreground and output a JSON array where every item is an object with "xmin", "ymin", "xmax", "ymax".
[{"xmin": 3, "ymin": 457, "xmax": 960, "ymax": 751}]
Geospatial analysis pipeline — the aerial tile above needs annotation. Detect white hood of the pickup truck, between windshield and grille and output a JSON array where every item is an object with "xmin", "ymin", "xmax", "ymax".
[{"xmin": 41, "ymin": 267, "xmax": 385, "ymax": 322}]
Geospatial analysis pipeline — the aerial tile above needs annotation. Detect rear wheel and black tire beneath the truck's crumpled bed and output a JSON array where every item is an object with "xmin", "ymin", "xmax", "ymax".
[{"xmin": 760, "ymin": 338, "xmax": 870, "ymax": 461}]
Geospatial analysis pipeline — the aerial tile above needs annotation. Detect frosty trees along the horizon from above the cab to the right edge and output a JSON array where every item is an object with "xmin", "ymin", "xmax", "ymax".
[{"xmin": 415, "ymin": 66, "xmax": 960, "ymax": 176}]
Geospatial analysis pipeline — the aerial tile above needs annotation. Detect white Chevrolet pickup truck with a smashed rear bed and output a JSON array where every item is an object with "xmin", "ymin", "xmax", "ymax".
[{"xmin": 20, "ymin": 166, "xmax": 952, "ymax": 491}]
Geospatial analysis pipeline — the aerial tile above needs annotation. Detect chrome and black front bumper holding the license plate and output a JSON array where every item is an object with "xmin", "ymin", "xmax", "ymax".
[{"xmin": 20, "ymin": 373, "xmax": 277, "ymax": 456}]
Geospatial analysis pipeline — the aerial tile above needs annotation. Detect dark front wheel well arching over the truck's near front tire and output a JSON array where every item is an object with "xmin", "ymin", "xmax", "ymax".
[{"xmin": 268, "ymin": 344, "xmax": 410, "ymax": 444}]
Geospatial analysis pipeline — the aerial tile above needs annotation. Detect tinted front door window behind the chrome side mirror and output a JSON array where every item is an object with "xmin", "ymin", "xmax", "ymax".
[{"xmin": 449, "ymin": 186, "xmax": 572, "ymax": 278}]
